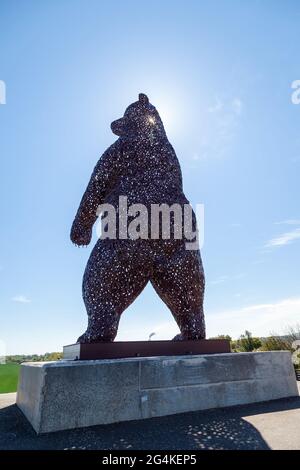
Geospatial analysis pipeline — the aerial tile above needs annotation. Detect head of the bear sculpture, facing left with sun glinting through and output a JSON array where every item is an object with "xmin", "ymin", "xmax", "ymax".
[{"xmin": 111, "ymin": 93, "xmax": 166, "ymax": 139}]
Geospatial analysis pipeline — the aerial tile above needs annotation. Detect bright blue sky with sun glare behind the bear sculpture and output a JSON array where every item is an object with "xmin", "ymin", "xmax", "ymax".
[{"xmin": 0, "ymin": 0, "xmax": 300, "ymax": 354}]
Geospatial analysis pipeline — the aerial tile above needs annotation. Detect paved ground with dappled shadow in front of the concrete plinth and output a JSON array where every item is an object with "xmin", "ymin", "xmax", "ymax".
[{"xmin": 0, "ymin": 384, "xmax": 300, "ymax": 450}]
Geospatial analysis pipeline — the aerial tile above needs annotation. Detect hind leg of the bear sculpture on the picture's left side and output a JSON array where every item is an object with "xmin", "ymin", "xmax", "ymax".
[{"xmin": 77, "ymin": 242, "xmax": 149, "ymax": 343}]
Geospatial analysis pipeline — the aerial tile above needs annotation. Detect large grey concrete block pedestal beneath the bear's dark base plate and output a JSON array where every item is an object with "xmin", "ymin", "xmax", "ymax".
[{"xmin": 17, "ymin": 351, "xmax": 298, "ymax": 433}]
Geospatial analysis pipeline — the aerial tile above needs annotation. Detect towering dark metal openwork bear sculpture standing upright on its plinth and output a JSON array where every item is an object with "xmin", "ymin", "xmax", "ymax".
[{"xmin": 71, "ymin": 94, "xmax": 205, "ymax": 343}]
